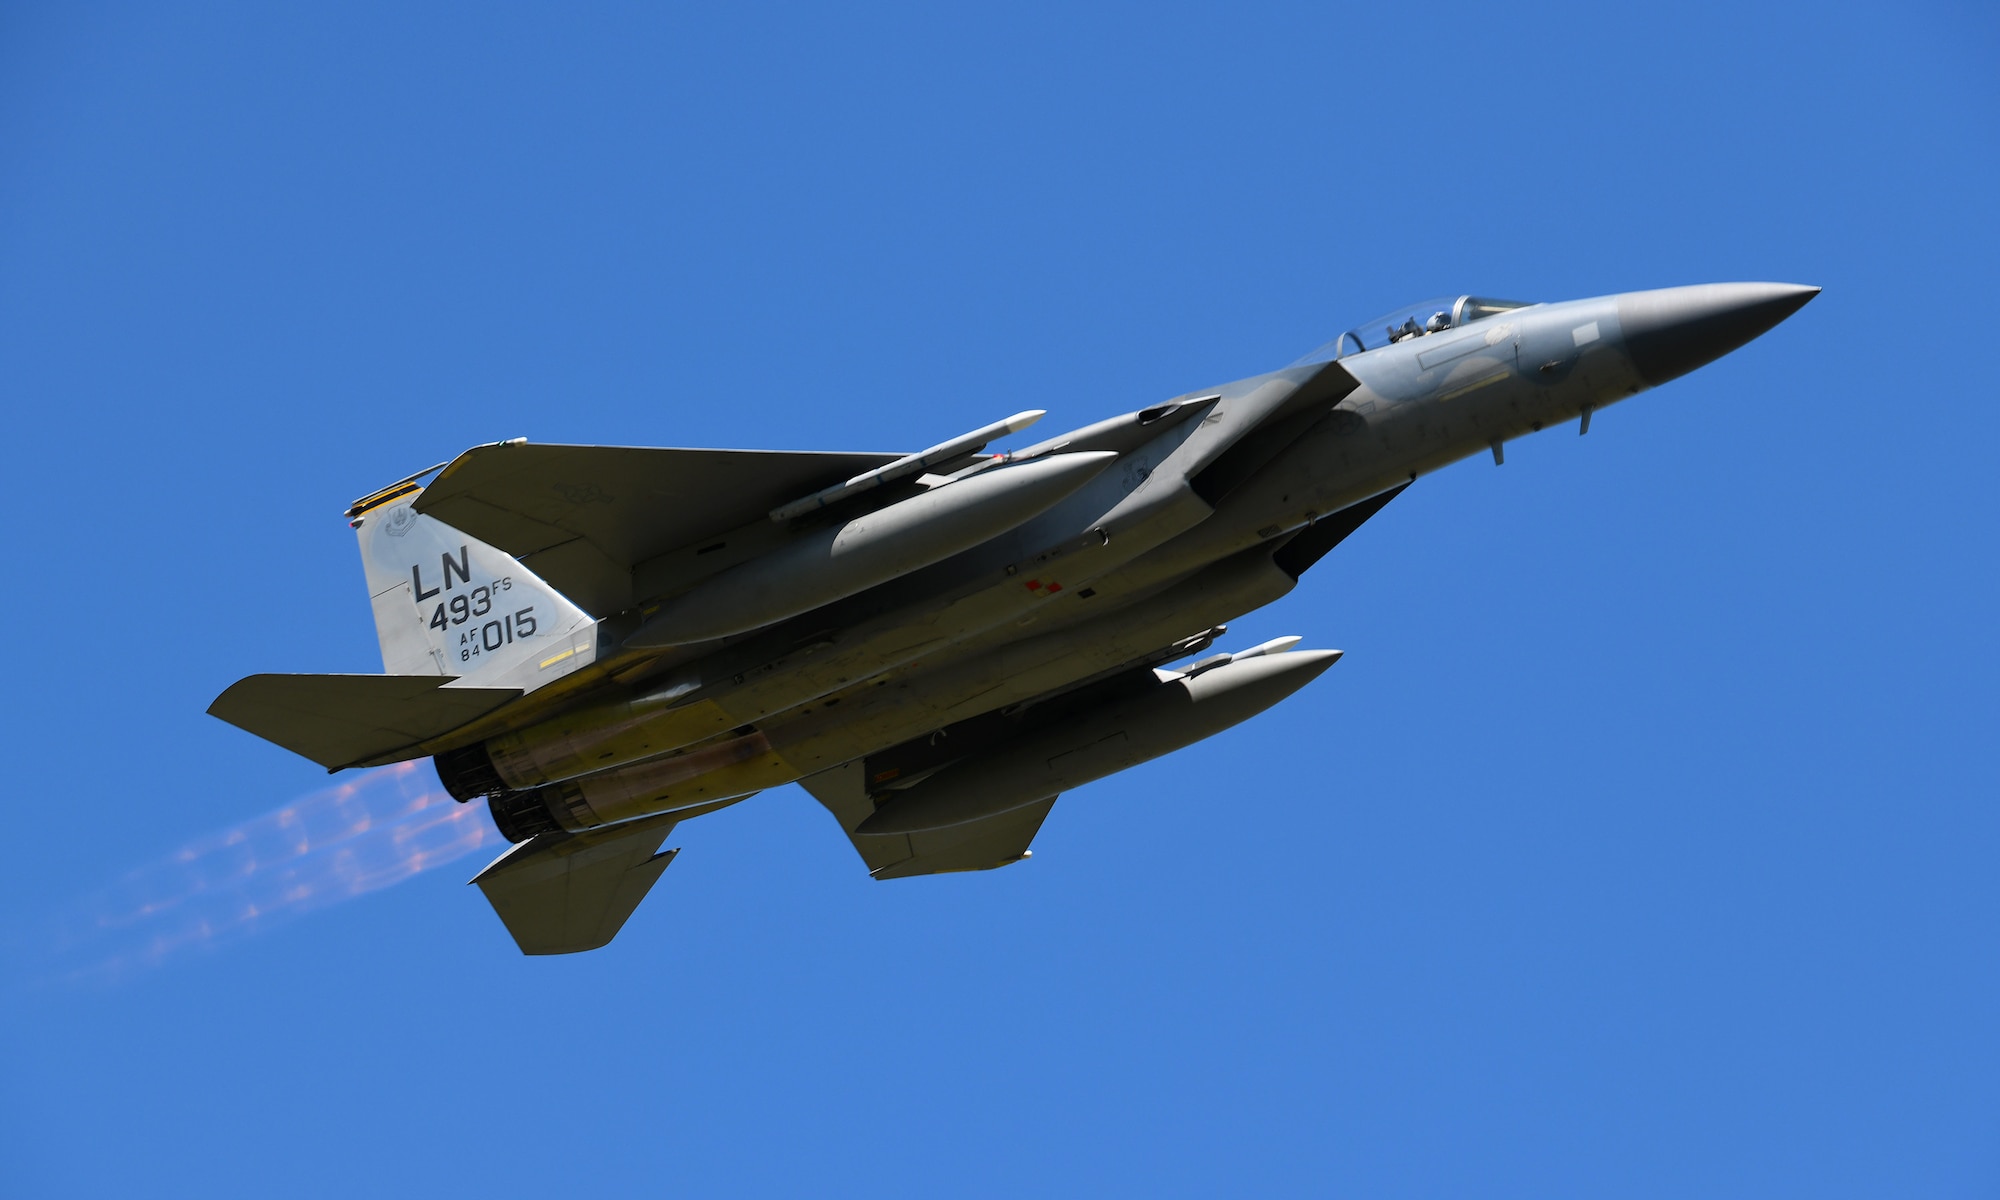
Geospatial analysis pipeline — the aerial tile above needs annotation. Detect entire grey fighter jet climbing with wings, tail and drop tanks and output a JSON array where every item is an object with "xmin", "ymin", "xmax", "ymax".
[{"xmin": 208, "ymin": 284, "xmax": 1818, "ymax": 954}]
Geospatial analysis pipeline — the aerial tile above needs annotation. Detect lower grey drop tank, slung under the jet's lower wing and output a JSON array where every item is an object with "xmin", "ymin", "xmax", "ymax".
[{"xmin": 854, "ymin": 646, "xmax": 1340, "ymax": 836}]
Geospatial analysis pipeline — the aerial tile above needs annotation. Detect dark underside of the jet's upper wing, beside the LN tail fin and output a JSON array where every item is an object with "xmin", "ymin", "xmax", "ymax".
[{"xmin": 416, "ymin": 442, "xmax": 898, "ymax": 618}]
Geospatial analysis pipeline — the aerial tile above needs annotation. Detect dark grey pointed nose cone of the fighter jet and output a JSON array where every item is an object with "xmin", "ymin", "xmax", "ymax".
[{"xmin": 1618, "ymin": 284, "xmax": 1820, "ymax": 386}]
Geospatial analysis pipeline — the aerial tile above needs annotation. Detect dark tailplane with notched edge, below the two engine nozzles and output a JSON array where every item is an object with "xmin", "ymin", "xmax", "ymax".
[{"xmin": 472, "ymin": 812, "xmax": 684, "ymax": 954}]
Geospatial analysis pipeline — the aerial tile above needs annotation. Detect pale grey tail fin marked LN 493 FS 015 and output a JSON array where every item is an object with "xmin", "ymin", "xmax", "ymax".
[{"xmin": 348, "ymin": 468, "xmax": 596, "ymax": 692}]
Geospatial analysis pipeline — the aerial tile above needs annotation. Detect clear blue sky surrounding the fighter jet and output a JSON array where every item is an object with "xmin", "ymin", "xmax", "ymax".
[{"xmin": 0, "ymin": 4, "xmax": 2000, "ymax": 1196}]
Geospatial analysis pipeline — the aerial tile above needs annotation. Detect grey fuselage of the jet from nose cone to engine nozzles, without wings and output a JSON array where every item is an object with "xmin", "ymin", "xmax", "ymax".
[{"xmin": 440, "ymin": 284, "xmax": 1812, "ymax": 834}]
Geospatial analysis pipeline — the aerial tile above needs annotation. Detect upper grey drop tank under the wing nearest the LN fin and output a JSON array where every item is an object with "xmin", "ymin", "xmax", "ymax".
[{"xmin": 626, "ymin": 450, "xmax": 1118, "ymax": 650}]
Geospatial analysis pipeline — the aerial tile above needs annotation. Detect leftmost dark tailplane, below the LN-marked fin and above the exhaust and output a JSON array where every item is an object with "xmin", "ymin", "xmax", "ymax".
[{"xmin": 208, "ymin": 674, "xmax": 520, "ymax": 770}]
